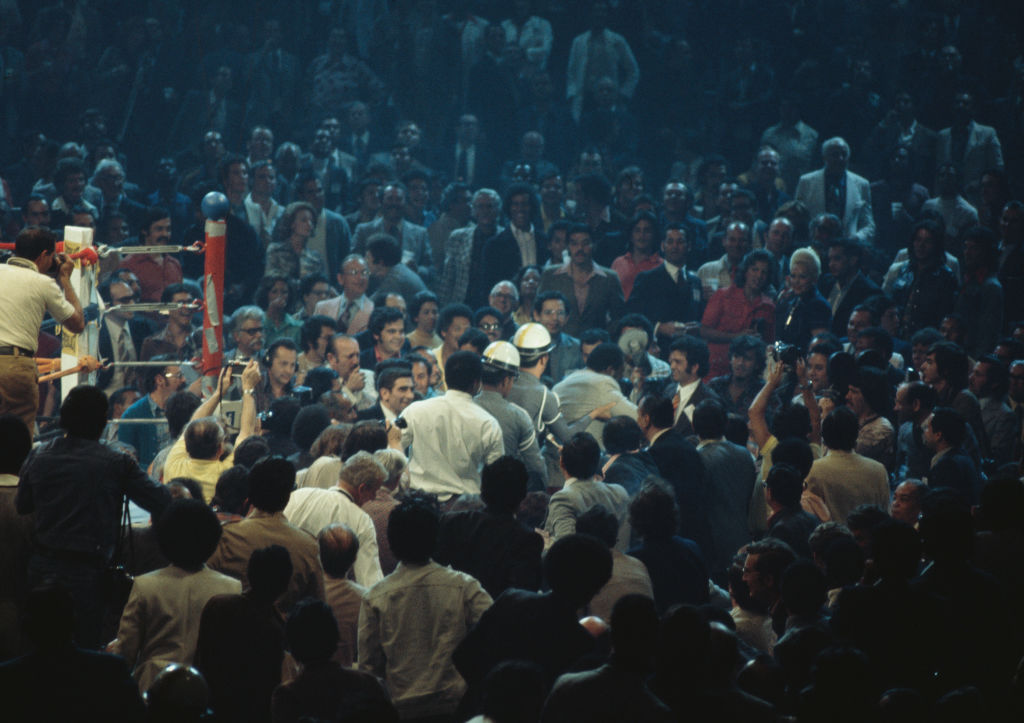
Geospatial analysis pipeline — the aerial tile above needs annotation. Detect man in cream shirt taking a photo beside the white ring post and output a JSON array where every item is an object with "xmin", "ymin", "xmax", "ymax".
[{"xmin": 0, "ymin": 226, "xmax": 85, "ymax": 430}]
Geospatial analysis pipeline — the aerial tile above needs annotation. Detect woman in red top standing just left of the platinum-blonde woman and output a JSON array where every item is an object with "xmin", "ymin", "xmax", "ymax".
[{"xmin": 700, "ymin": 249, "xmax": 775, "ymax": 378}]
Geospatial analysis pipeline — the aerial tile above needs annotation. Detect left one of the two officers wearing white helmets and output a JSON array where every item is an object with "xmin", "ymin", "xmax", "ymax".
[{"xmin": 475, "ymin": 341, "xmax": 548, "ymax": 490}]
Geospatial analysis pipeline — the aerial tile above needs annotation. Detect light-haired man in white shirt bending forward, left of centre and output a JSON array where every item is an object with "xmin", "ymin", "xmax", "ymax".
[{"xmin": 285, "ymin": 452, "xmax": 387, "ymax": 587}]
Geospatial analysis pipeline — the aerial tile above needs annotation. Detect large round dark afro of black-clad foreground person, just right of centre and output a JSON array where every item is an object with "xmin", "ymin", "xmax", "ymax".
[{"xmin": 544, "ymin": 535, "xmax": 611, "ymax": 608}]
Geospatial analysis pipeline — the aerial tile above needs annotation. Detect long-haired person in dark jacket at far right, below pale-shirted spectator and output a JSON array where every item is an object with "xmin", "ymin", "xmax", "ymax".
[{"xmin": 882, "ymin": 220, "xmax": 959, "ymax": 338}]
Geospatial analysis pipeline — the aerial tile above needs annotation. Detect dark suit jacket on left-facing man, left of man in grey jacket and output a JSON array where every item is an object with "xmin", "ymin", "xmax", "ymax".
[{"xmin": 647, "ymin": 429, "xmax": 711, "ymax": 558}]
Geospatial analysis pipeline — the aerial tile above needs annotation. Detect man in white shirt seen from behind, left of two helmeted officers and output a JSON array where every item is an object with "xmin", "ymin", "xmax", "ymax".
[{"xmin": 399, "ymin": 351, "xmax": 505, "ymax": 502}]
